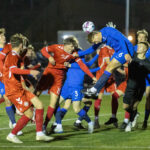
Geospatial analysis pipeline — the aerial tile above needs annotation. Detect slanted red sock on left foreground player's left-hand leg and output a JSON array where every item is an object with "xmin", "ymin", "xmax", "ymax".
[{"xmin": 11, "ymin": 115, "xmax": 31, "ymax": 135}]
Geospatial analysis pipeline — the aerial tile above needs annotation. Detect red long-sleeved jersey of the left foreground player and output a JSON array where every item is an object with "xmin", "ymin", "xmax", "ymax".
[{"xmin": 3, "ymin": 50, "xmax": 30, "ymax": 96}]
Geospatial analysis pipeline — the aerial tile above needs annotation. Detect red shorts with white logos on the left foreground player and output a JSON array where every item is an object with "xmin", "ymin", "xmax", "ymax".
[{"xmin": 8, "ymin": 90, "xmax": 35, "ymax": 113}]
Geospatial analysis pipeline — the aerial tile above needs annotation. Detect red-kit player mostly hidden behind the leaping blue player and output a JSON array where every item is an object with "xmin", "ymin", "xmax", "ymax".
[{"xmin": 94, "ymin": 45, "xmax": 126, "ymax": 128}]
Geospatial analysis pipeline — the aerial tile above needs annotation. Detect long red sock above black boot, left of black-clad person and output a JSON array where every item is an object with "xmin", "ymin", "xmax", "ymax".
[{"xmin": 111, "ymin": 92, "xmax": 119, "ymax": 116}]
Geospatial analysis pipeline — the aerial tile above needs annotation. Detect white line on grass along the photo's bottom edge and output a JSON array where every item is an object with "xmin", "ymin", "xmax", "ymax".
[{"xmin": 0, "ymin": 145, "xmax": 150, "ymax": 149}]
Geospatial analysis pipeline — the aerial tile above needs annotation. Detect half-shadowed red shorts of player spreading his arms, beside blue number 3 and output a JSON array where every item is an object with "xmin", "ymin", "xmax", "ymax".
[{"xmin": 36, "ymin": 67, "xmax": 64, "ymax": 95}]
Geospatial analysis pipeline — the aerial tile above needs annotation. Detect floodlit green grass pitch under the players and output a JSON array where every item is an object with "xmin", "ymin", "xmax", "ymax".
[{"xmin": 0, "ymin": 95, "xmax": 150, "ymax": 150}]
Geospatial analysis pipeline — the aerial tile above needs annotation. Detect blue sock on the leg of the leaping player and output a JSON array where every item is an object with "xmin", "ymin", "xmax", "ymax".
[{"xmin": 94, "ymin": 71, "xmax": 111, "ymax": 93}]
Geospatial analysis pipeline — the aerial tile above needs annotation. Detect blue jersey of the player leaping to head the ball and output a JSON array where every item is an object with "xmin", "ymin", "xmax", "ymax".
[{"xmin": 78, "ymin": 27, "xmax": 134, "ymax": 56}]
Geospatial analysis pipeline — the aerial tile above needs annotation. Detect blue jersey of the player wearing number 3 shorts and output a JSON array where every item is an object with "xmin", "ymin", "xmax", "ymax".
[{"xmin": 65, "ymin": 52, "xmax": 100, "ymax": 87}]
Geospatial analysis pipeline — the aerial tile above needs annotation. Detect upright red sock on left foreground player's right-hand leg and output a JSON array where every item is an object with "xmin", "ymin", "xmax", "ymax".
[{"xmin": 35, "ymin": 109, "xmax": 44, "ymax": 132}]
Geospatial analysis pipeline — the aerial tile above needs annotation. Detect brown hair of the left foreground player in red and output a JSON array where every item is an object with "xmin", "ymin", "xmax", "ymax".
[{"xmin": 10, "ymin": 35, "xmax": 23, "ymax": 48}]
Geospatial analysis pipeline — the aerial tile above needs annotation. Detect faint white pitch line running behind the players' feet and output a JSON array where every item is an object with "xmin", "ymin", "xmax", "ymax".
[{"xmin": 0, "ymin": 112, "xmax": 124, "ymax": 130}]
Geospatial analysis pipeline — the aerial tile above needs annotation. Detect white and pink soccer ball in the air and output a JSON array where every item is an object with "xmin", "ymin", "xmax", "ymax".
[{"xmin": 82, "ymin": 21, "xmax": 95, "ymax": 33}]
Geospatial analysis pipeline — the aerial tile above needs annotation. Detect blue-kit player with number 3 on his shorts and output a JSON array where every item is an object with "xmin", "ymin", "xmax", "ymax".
[{"xmin": 54, "ymin": 50, "xmax": 100, "ymax": 133}]
